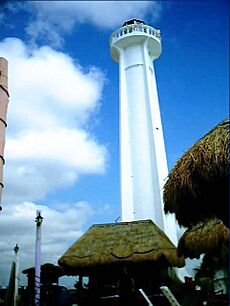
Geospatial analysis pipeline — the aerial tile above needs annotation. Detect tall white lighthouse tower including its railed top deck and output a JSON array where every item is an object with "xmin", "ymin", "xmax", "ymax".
[{"xmin": 110, "ymin": 19, "xmax": 177, "ymax": 244}]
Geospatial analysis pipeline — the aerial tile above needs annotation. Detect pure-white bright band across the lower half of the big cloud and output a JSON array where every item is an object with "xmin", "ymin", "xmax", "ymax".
[{"xmin": 6, "ymin": 128, "xmax": 106, "ymax": 173}]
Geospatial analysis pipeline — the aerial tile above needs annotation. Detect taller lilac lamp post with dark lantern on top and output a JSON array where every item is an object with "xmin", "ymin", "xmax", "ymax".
[{"xmin": 34, "ymin": 210, "xmax": 43, "ymax": 306}]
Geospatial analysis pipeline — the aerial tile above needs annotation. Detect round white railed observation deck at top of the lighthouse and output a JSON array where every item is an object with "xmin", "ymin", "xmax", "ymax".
[{"xmin": 110, "ymin": 22, "xmax": 161, "ymax": 62}]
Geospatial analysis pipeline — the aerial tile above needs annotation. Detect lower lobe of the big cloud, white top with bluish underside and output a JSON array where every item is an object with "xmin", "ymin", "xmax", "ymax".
[{"xmin": 5, "ymin": 128, "xmax": 106, "ymax": 202}]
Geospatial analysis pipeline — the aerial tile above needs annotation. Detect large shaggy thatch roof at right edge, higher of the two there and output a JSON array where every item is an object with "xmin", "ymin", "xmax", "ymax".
[{"xmin": 163, "ymin": 120, "xmax": 229, "ymax": 227}]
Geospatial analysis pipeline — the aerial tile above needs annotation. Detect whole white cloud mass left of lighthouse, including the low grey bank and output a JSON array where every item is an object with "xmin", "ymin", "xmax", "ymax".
[{"xmin": 0, "ymin": 38, "xmax": 108, "ymax": 284}]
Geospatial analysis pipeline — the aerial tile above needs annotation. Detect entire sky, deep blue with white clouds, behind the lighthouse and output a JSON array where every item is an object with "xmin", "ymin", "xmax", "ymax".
[{"xmin": 0, "ymin": 0, "xmax": 229, "ymax": 285}]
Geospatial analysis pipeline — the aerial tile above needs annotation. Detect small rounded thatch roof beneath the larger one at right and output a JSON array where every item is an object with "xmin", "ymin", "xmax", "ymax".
[{"xmin": 178, "ymin": 218, "xmax": 229, "ymax": 258}]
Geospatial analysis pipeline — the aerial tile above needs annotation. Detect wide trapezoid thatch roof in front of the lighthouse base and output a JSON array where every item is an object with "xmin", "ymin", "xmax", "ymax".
[{"xmin": 58, "ymin": 220, "xmax": 184, "ymax": 275}]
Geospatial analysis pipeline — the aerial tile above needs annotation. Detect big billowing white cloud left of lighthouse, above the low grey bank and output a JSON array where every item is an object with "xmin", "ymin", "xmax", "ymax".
[{"xmin": 0, "ymin": 38, "xmax": 107, "ymax": 202}]
